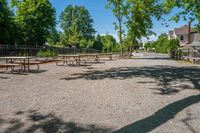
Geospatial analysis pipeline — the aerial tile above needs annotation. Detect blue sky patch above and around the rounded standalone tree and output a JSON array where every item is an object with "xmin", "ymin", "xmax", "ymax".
[{"xmin": 50, "ymin": 0, "xmax": 116, "ymax": 34}]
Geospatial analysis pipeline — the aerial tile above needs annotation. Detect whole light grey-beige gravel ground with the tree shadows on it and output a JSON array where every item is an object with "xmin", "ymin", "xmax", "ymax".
[{"xmin": 0, "ymin": 54, "xmax": 200, "ymax": 133}]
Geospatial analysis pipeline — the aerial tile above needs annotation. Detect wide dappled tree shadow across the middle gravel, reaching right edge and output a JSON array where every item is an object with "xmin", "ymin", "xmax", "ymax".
[{"xmin": 61, "ymin": 66, "xmax": 200, "ymax": 95}]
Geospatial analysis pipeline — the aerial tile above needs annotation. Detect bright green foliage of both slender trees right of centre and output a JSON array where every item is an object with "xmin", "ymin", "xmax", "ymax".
[{"xmin": 108, "ymin": 0, "xmax": 163, "ymax": 53}]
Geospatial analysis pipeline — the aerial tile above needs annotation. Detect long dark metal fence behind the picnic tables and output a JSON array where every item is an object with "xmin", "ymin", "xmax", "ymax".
[{"xmin": 0, "ymin": 45, "xmax": 101, "ymax": 56}]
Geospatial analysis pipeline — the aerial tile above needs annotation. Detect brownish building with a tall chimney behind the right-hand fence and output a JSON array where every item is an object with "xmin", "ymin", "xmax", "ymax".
[{"xmin": 169, "ymin": 23, "xmax": 200, "ymax": 46}]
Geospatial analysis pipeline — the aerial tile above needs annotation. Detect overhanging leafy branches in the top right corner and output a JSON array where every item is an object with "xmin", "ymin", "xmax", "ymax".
[{"xmin": 163, "ymin": 0, "xmax": 200, "ymax": 32}]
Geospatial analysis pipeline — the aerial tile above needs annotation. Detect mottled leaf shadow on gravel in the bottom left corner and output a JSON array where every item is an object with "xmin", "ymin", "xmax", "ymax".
[{"xmin": 0, "ymin": 110, "xmax": 111, "ymax": 133}]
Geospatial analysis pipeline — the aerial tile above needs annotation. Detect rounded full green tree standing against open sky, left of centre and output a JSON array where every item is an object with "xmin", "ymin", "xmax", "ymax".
[{"xmin": 60, "ymin": 5, "xmax": 95, "ymax": 45}]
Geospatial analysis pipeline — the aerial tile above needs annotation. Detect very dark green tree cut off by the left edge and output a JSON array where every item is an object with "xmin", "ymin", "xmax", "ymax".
[{"xmin": 0, "ymin": 0, "xmax": 16, "ymax": 45}]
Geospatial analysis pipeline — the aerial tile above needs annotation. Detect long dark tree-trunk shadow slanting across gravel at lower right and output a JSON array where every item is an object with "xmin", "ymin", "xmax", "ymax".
[{"xmin": 113, "ymin": 94, "xmax": 200, "ymax": 133}]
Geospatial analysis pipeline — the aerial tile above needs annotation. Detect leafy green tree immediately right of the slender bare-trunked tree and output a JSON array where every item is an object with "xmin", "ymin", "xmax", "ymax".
[{"xmin": 126, "ymin": 0, "xmax": 162, "ymax": 55}]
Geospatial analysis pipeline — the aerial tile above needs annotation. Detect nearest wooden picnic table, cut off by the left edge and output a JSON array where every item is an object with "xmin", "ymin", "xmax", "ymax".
[{"xmin": 0, "ymin": 56, "xmax": 39, "ymax": 72}]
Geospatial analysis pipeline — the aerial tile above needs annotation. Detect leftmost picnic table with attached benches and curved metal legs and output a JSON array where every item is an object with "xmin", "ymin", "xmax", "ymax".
[{"xmin": 0, "ymin": 56, "xmax": 39, "ymax": 72}]
